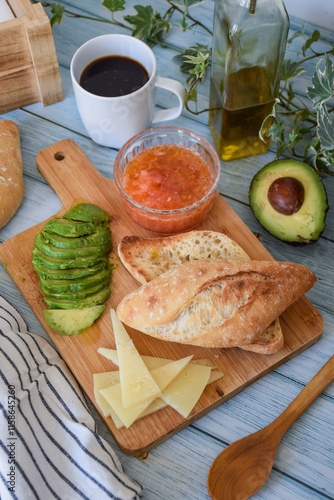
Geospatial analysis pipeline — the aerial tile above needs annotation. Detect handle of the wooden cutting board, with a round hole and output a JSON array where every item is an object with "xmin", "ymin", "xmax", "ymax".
[{"xmin": 36, "ymin": 139, "xmax": 110, "ymax": 208}]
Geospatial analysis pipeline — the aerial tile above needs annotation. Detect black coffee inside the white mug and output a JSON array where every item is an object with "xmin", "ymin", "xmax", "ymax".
[{"xmin": 79, "ymin": 56, "xmax": 149, "ymax": 97}]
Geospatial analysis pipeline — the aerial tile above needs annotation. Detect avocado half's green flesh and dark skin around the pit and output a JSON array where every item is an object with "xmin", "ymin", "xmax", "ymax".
[{"xmin": 249, "ymin": 159, "xmax": 328, "ymax": 246}]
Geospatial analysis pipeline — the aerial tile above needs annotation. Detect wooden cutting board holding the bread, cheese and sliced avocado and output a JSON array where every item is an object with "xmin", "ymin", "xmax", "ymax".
[{"xmin": 0, "ymin": 140, "xmax": 323, "ymax": 455}]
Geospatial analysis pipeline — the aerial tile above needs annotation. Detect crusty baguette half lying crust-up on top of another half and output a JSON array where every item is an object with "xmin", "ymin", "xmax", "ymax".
[{"xmin": 117, "ymin": 259, "xmax": 316, "ymax": 348}]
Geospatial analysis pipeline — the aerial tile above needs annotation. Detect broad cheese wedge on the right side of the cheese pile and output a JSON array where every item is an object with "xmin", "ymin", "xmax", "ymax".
[{"xmin": 160, "ymin": 363, "xmax": 211, "ymax": 418}]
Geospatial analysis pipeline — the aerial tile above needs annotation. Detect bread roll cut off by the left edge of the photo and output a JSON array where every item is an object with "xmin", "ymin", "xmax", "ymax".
[{"xmin": 0, "ymin": 120, "xmax": 24, "ymax": 229}]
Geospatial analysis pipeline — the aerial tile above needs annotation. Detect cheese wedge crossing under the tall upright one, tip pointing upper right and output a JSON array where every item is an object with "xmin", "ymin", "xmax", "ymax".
[{"xmin": 100, "ymin": 356, "xmax": 192, "ymax": 428}]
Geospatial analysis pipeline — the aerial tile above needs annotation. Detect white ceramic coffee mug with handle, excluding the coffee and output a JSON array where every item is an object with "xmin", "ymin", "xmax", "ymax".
[{"xmin": 71, "ymin": 34, "xmax": 185, "ymax": 149}]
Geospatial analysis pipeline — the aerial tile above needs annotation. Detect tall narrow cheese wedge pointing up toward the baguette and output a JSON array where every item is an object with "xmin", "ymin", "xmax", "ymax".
[{"xmin": 110, "ymin": 309, "xmax": 161, "ymax": 408}]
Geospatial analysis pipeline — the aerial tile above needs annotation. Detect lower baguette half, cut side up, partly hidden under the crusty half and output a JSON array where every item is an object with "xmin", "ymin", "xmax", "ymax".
[{"xmin": 118, "ymin": 231, "xmax": 284, "ymax": 354}]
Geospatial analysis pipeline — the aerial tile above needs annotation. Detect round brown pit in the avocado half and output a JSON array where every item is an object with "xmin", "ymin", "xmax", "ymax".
[{"xmin": 268, "ymin": 177, "xmax": 305, "ymax": 215}]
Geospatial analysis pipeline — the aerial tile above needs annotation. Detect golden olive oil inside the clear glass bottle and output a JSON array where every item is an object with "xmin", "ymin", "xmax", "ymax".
[{"xmin": 209, "ymin": 66, "xmax": 274, "ymax": 161}]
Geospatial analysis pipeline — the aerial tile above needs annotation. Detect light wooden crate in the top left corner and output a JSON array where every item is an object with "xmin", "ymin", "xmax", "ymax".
[{"xmin": 0, "ymin": 0, "xmax": 63, "ymax": 114}]
